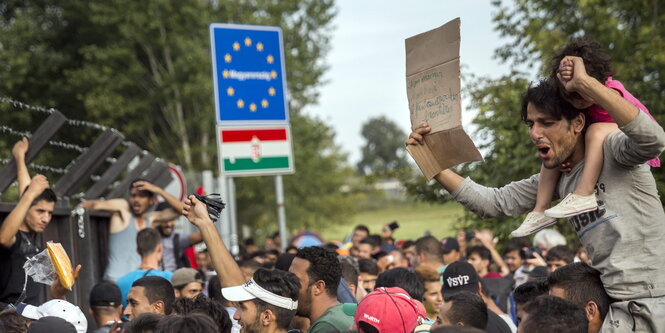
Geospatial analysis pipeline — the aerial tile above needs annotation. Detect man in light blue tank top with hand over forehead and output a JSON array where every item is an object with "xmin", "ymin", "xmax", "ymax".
[{"xmin": 79, "ymin": 179, "xmax": 182, "ymax": 281}]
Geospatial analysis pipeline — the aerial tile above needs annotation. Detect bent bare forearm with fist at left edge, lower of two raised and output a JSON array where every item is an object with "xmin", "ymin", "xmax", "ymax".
[{"xmin": 0, "ymin": 175, "xmax": 49, "ymax": 248}]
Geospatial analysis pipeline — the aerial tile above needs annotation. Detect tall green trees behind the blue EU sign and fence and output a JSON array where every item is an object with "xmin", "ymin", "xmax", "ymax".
[{"xmin": 0, "ymin": 0, "xmax": 353, "ymax": 233}]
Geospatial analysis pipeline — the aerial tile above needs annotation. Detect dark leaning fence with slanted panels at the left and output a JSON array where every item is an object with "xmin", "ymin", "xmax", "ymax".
[{"xmin": 0, "ymin": 97, "xmax": 172, "ymax": 330}]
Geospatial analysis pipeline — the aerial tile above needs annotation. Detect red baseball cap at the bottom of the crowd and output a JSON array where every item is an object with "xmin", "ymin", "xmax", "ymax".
[{"xmin": 354, "ymin": 287, "xmax": 427, "ymax": 333}]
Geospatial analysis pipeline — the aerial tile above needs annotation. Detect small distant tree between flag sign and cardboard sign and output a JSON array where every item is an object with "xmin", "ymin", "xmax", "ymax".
[{"xmin": 357, "ymin": 116, "xmax": 410, "ymax": 176}]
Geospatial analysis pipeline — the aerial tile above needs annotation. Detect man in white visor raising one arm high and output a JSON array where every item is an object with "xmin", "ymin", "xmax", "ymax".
[{"xmin": 182, "ymin": 196, "xmax": 298, "ymax": 333}]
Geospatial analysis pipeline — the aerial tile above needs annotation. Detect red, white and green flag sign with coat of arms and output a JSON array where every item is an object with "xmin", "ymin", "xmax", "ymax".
[{"xmin": 217, "ymin": 125, "xmax": 294, "ymax": 176}]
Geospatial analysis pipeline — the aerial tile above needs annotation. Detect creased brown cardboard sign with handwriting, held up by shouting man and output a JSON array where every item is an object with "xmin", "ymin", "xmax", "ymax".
[{"xmin": 406, "ymin": 18, "xmax": 483, "ymax": 179}]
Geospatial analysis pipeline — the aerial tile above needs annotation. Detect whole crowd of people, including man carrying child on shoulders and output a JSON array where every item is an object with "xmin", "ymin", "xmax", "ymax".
[{"xmin": 0, "ymin": 40, "xmax": 665, "ymax": 333}]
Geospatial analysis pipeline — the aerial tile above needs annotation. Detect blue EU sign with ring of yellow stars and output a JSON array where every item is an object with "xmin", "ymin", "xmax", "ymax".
[{"xmin": 210, "ymin": 23, "xmax": 289, "ymax": 125}]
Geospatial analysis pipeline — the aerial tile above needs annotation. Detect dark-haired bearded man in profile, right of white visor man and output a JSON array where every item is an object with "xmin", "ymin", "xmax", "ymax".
[{"xmin": 289, "ymin": 246, "xmax": 353, "ymax": 333}]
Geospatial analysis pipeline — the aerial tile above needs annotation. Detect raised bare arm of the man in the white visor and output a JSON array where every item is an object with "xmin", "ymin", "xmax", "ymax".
[{"xmin": 182, "ymin": 195, "xmax": 245, "ymax": 287}]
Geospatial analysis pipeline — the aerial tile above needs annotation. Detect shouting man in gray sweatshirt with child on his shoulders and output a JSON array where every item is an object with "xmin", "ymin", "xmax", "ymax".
[{"xmin": 407, "ymin": 57, "xmax": 665, "ymax": 332}]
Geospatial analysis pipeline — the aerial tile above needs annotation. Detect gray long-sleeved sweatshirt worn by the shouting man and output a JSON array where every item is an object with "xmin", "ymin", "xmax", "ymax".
[{"xmin": 452, "ymin": 112, "xmax": 665, "ymax": 300}]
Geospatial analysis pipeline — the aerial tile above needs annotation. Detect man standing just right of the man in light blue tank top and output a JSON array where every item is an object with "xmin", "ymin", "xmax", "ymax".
[{"xmin": 152, "ymin": 202, "xmax": 203, "ymax": 272}]
